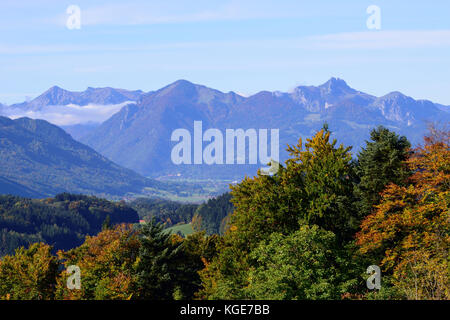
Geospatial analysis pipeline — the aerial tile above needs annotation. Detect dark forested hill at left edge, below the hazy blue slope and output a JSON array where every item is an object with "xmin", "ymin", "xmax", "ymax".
[{"xmin": 0, "ymin": 193, "xmax": 138, "ymax": 256}]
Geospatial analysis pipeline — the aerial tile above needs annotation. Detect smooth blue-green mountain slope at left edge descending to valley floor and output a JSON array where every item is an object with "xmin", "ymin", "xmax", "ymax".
[{"xmin": 0, "ymin": 117, "xmax": 159, "ymax": 196}]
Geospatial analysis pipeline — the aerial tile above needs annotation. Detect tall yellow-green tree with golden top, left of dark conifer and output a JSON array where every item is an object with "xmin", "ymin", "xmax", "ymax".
[{"xmin": 286, "ymin": 125, "xmax": 357, "ymax": 241}]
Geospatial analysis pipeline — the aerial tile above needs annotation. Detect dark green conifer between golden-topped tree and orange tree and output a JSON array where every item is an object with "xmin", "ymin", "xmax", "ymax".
[{"xmin": 355, "ymin": 126, "xmax": 411, "ymax": 218}]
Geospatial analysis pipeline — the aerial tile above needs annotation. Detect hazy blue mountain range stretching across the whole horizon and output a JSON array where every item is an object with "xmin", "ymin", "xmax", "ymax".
[{"xmin": 3, "ymin": 78, "xmax": 450, "ymax": 179}]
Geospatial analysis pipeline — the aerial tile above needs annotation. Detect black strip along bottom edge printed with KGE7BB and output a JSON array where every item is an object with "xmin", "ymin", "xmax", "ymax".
[{"xmin": 0, "ymin": 300, "xmax": 450, "ymax": 320}]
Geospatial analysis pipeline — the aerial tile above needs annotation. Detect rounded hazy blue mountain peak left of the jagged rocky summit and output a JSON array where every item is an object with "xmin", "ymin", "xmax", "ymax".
[{"xmin": 81, "ymin": 80, "xmax": 243, "ymax": 175}]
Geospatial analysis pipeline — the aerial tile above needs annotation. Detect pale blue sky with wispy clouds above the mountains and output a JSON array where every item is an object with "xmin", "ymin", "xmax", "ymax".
[{"xmin": 0, "ymin": 0, "xmax": 450, "ymax": 105}]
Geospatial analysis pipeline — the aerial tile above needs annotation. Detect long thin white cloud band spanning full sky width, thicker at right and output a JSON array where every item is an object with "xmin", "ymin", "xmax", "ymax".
[{"xmin": 0, "ymin": 30, "xmax": 450, "ymax": 54}]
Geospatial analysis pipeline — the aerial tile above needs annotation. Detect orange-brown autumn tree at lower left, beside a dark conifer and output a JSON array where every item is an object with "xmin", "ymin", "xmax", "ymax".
[{"xmin": 56, "ymin": 224, "xmax": 140, "ymax": 300}]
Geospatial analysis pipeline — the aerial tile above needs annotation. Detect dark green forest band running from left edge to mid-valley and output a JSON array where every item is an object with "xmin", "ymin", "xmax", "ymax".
[{"xmin": 0, "ymin": 193, "xmax": 233, "ymax": 256}]
